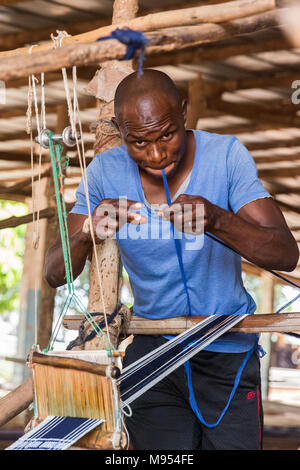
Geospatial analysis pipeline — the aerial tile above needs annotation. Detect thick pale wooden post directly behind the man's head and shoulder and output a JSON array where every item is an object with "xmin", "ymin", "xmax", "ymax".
[{"xmin": 88, "ymin": 0, "xmax": 138, "ymax": 313}]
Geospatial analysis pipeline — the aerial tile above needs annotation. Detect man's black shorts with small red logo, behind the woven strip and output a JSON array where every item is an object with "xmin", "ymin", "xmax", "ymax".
[{"xmin": 124, "ymin": 335, "xmax": 263, "ymax": 450}]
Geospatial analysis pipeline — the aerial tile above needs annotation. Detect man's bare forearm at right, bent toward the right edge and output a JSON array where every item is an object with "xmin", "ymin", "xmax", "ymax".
[{"xmin": 211, "ymin": 206, "xmax": 299, "ymax": 271}]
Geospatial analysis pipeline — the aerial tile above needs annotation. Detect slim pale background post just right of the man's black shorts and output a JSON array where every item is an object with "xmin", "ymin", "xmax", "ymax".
[{"xmin": 260, "ymin": 272, "xmax": 275, "ymax": 400}]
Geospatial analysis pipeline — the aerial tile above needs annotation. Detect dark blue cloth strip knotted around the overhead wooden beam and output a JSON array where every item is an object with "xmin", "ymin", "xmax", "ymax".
[{"xmin": 97, "ymin": 28, "xmax": 149, "ymax": 75}]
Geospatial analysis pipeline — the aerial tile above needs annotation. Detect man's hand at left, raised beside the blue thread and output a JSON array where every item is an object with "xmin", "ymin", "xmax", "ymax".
[{"xmin": 87, "ymin": 198, "xmax": 147, "ymax": 240}]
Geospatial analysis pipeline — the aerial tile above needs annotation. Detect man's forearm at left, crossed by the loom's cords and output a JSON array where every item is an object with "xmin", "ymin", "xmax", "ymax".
[{"xmin": 44, "ymin": 231, "xmax": 93, "ymax": 287}]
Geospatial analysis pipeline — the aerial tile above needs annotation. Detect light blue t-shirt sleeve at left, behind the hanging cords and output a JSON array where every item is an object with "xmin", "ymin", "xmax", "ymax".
[{"xmin": 70, "ymin": 157, "xmax": 104, "ymax": 215}]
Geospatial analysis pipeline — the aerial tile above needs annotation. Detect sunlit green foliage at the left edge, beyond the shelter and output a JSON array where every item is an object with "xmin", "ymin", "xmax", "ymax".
[{"xmin": 0, "ymin": 201, "xmax": 28, "ymax": 315}]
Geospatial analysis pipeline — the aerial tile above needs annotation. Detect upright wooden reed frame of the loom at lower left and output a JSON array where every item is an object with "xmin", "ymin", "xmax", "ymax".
[{"xmin": 29, "ymin": 351, "xmax": 127, "ymax": 449}]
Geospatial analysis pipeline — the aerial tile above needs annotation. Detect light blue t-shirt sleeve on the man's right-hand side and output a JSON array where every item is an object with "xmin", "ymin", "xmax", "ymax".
[{"xmin": 227, "ymin": 139, "xmax": 271, "ymax": 213}]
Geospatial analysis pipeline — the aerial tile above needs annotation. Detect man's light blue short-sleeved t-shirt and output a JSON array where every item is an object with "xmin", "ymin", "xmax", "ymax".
[{"xmin": 71, "ymin": 130, "xmax": 270, "ymax": 352}]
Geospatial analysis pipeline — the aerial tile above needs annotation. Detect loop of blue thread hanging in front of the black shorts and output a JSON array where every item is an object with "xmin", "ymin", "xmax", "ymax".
[{"xmin": 184, "ymin": 342, "xmax": 260, "ymax": 428}]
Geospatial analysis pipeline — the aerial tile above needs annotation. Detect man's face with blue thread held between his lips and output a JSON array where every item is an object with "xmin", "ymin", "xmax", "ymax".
[{"xmin": 117, "ymin": 91, "xmax": 186, "ymax": 178}]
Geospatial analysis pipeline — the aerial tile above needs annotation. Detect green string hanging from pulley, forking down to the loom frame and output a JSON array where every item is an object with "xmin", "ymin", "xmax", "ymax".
[{"xmin": 44, "ymin": 132, "xmax": 116, "ymax": 356}]
